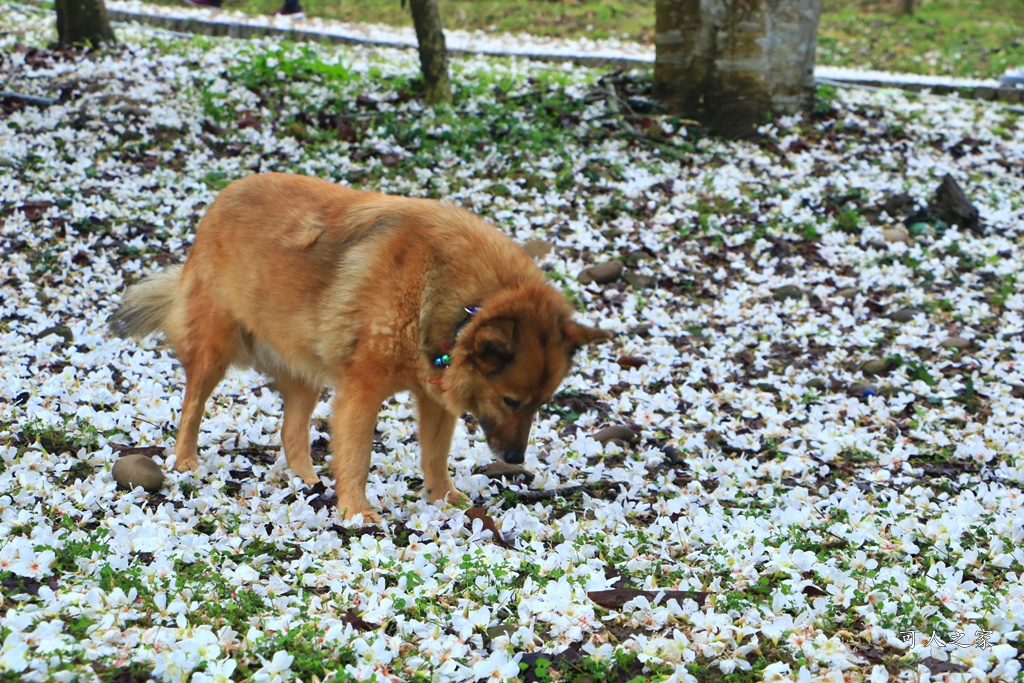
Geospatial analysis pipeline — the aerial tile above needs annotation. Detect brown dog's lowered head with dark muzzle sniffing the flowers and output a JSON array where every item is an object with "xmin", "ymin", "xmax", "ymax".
[{"xmin": 447, "ymin": 286, "xmax": 611, "ymax": 464}]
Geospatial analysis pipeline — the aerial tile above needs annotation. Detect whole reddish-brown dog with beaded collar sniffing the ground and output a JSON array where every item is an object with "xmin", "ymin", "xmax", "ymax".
[{"xmin": 110, "ymin": 174, "xmax": 610, "ymax": 520}]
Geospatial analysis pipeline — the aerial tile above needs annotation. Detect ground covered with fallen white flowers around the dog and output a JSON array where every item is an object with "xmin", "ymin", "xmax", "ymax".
[{"xmin": 0, "ymin": 5, "xmax": 1024, "ymax": 683}]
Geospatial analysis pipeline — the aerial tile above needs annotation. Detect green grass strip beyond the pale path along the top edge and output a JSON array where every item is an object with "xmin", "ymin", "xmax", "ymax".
[{"xmin": 144, "ymin": 0, "xmax": 1024, "ymax": 78}]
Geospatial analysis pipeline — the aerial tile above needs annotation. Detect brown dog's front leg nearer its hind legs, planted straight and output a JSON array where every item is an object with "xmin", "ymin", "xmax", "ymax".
[{"xmin": 331, "ymin": 380, "xmax": 384, "ymax": 523}]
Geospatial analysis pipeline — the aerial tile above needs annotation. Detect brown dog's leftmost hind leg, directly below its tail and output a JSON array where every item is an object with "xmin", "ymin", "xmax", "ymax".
[{"xmin": 170, "ymin": 282, "xmax": 238, "ymax": 472}]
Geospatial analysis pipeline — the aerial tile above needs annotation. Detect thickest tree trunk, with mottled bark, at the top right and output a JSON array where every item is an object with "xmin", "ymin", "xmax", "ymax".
[{"xmin": 654, "ymin": 0, "xmax": 821, "ymax": 137}]
